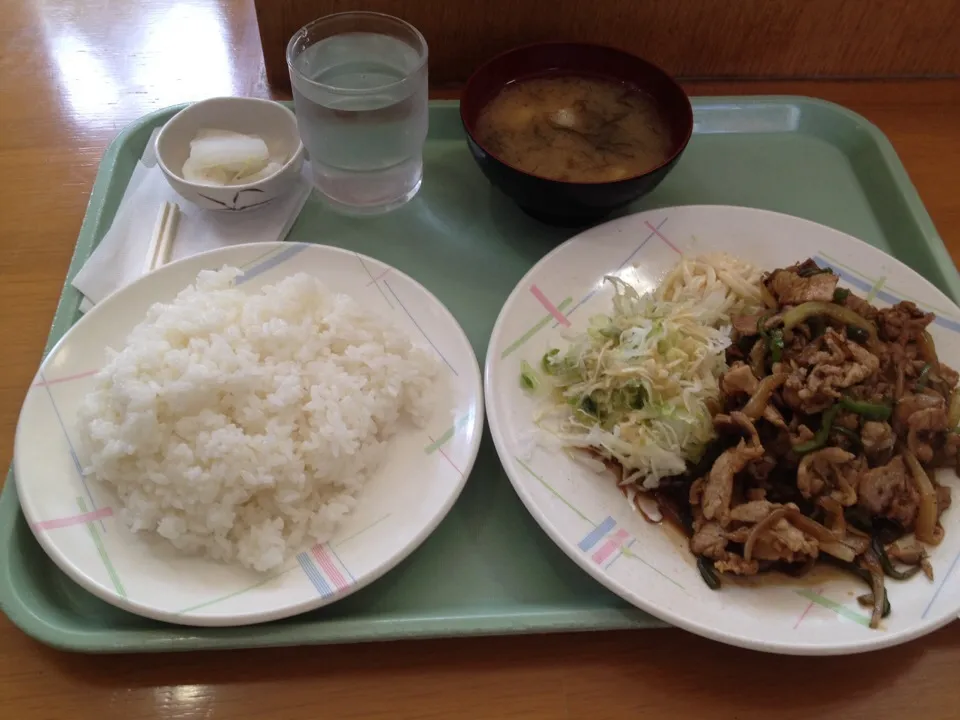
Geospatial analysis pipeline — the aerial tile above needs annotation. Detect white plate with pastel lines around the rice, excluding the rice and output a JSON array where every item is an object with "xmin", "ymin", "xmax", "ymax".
[{"xmin": 14, "ymin": 243, "xmax": 483, "ymax": 625}]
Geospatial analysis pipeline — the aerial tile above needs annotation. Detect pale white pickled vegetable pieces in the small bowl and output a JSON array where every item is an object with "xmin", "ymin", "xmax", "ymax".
[{"xmin": 183, "ymin": 129, "xmax": 285, "ymax": 185}]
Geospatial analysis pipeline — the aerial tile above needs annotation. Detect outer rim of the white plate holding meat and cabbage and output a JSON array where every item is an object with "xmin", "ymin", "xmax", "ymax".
[{"xmin": 483, "ymin": 204, "xmax": 960, "ymax": 656}]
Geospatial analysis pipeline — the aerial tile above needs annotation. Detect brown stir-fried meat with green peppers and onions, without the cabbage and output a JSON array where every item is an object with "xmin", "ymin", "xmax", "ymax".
[{"xmin": 656, "ymin": 260, "xmax": 960, "ymax": 627}]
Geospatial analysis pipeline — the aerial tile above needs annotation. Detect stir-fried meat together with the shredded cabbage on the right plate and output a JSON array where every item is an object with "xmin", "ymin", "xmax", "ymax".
[{"xmin": 520, "ymin": 253, "xmax": 960, "ymax": 627}]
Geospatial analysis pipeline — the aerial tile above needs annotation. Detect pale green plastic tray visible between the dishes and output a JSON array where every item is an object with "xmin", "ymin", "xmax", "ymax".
[{"xmin": 0, "ymin": 97, "xmax": 960, "ymax": 652}]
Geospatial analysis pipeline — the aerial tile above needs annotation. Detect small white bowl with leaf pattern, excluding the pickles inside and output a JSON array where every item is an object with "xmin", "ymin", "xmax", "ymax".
[{"xmin": 157, "ymin": 97, "xmax": 304, "ymax": 212}]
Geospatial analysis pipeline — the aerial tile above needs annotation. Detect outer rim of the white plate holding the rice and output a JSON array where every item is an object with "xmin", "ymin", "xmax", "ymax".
[{"xmin": 12, "ymin": 241, "xmax": 486, "ymax": 627}]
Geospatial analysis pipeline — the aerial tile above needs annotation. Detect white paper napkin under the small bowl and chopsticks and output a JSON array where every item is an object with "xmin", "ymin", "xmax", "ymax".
[{"xmin": 73, "ymin": 130, "xmax": 311, "ymax": 312}]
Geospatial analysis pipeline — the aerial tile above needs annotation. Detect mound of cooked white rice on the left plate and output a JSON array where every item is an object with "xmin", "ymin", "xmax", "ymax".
[{"xmin": 79, "ymin": 268, "xmax": 438, "ymax": 571}]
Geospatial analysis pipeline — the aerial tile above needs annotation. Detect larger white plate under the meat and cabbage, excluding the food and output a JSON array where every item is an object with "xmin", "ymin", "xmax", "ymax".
[{"xmin": 485, "ymin": 206, "xmax": 960, "ymax": 655}]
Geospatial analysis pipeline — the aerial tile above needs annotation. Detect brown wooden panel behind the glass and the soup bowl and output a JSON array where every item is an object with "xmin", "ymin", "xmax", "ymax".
[{"xmin": 255, "ymin": 0, "xmax": 960, "ymax": 88}]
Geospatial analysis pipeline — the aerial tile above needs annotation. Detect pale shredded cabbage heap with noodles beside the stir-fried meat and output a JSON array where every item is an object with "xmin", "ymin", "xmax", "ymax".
[{"xmin": 538, "ymin": 255, "xmax": 763, "ymax": 488}]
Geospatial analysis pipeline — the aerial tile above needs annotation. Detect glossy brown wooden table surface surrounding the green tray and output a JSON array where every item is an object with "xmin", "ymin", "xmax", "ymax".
[{"xmin": 0, "ymin": 0, "xmax": 960, "ymax": 720}]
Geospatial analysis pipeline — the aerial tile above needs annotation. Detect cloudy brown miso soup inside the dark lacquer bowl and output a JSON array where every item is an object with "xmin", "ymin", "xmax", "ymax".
[{"xmin": 475, "ymin": 75, "xmax": 671, "ymax": 182}]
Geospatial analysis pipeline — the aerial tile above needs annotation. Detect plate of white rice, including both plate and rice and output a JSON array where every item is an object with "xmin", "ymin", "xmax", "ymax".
[{"xmin": 14, "ymin": 243, "xmax": 483, "ymax": 626}]
